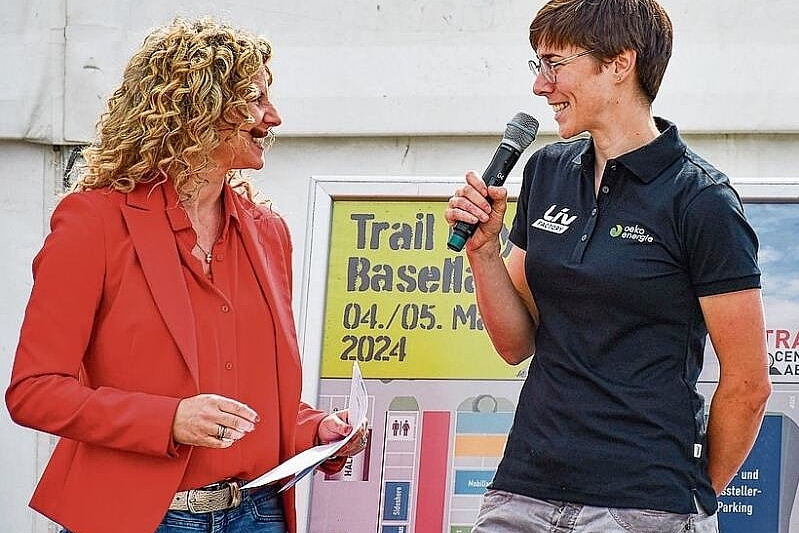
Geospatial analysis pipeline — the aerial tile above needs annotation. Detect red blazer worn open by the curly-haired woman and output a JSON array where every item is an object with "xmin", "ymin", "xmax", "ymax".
[{"xmin": 6, "ymin": 185, "xmax": 332, "ymax": 533}]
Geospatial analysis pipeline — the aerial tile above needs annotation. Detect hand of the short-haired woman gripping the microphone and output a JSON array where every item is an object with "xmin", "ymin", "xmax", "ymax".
[{"xmin": 444, "ymin": 170, "xmax": 508, "ymax": 252}]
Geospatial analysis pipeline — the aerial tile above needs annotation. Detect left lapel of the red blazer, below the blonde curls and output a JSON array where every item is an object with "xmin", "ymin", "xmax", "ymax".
[{"xmin": 122, "ymin": 185, "xmax": 199, "ymax": 383}]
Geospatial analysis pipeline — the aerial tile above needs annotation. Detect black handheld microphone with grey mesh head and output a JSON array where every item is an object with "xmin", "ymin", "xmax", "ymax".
[{"xmin": 447, "ymin": 111, "xmax": 538, "ymax": 252}]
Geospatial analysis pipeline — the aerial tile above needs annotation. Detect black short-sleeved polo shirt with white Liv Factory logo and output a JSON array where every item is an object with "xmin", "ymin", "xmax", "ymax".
[{"xmin": 492, "ymin": 119, "xmax": 760, "ymax": 513}]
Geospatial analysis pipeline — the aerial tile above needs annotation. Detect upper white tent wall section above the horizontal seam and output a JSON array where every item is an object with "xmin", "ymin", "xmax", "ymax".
[{"xmin": 0, "ymin": 0, "xmax": 799, "ymax": 144}]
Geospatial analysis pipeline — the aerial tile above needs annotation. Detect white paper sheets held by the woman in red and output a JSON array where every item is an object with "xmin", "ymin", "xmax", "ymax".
[{"xmin": 242, "ymin": 362, "xmax": 369, "ymax": 489}]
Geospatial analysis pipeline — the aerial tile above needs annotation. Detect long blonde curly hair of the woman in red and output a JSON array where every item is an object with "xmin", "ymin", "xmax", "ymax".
[{"xmin": 74, "ymin": 18, "xmax": 272, "ymax": 200}]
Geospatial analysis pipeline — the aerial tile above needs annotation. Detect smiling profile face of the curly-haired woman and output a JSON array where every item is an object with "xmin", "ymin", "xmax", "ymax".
[{"xmin": 209, "ymin": 68, "xmax": 282, "ymax": 171}]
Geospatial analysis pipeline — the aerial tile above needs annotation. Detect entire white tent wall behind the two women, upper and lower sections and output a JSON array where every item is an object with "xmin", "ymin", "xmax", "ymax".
[{"xmin": 0, "ymin": 0, "xmax": 799, "ymax": 533}]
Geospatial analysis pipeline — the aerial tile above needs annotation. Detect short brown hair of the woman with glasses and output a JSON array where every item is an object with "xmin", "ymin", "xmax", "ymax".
[{"xmin": 530, "ymin": 0, "xmax": 674, "ymax": 103}]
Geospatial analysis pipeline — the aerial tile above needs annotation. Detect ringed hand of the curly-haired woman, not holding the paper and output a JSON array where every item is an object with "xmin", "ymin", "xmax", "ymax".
[{"xmin": 172, "ymin": 394, "xmax": 260, "ymax": 448}]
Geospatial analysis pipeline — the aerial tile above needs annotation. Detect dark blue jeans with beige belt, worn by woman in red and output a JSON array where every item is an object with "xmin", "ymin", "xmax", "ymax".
[{"xmin": 61, "ymin": 487, "xmax": 286, "ymax": 533}]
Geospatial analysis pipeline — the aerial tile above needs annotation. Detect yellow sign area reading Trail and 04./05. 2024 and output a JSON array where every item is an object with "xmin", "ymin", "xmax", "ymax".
[{"xmin": 321, "ymin": 200, "xmax": 521, "ymax": 379}]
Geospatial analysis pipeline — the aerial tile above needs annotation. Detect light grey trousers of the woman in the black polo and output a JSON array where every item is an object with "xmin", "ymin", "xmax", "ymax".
[{"xmin": 472, "ymin": 490, "xmax": 719, "ymax": 533}]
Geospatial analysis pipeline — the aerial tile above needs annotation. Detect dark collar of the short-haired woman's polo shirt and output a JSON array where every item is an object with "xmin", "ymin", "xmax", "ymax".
[{"xmin": 574, "ymin": 117, "xmax": 687, "ymax": 183}]
